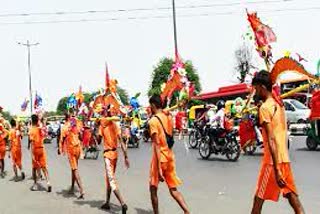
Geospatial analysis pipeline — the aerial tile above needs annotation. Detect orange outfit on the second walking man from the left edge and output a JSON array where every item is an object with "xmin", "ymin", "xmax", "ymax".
[{"xmin": 9, "ymin": 128, "xmax": 22, "ymax": 168}]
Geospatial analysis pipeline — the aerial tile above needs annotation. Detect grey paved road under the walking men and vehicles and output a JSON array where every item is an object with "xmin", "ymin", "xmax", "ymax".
[{"xmin": 0, "ymin": 137, "xmax": 320, "ymax": 214}]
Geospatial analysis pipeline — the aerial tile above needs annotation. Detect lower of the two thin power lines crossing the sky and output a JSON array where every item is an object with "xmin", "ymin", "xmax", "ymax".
[{"xmin": 0, "ymin": 7, "xmax": 320, "ymax": 25}]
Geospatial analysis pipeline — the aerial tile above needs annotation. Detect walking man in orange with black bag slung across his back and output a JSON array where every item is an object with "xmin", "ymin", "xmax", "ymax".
[{"xmin": 149, "ymin": 96, "xmax": 189, "ymax": 214}]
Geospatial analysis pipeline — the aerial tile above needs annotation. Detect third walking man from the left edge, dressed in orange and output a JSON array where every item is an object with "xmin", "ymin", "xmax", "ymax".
[{"xmin": 29, "ymin": 114, "xmax": 52, "ymax": 192}]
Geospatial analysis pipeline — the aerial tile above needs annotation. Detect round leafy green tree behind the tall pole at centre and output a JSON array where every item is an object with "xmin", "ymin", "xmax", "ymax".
[{"xmin": 148, "ymin": 58, "xmax": 201, "ymax": 102}]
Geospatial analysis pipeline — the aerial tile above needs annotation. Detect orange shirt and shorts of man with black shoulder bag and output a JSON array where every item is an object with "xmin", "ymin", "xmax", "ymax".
[{"xmin": 149, "ymin": 113, "xmax": 182, "ymax": 188}]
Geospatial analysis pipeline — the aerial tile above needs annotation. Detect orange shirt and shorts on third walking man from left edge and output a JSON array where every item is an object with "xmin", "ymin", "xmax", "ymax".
[{"xmin": 29, "ymin": 126, "xmax": 47, "ymax": 169}]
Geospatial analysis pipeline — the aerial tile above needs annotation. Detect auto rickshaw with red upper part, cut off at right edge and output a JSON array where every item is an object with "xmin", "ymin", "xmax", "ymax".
[{"xmin": 306, "ymin": 90, "xmax": 320, "ymax": 151}]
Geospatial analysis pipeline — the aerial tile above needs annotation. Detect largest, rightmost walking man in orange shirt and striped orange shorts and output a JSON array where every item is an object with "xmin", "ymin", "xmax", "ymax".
[{"xmin": 252, "ymin": 71, "xmax": 304, "ymax": 214}]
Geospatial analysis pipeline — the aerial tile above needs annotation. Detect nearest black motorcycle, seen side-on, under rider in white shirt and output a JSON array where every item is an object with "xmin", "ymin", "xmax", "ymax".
[{"xmin": 199, "ymin": 124, "xmax": 241, "ymax": 161}]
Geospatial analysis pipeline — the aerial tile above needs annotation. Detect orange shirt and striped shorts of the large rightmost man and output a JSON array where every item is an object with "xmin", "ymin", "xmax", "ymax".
[{"xmin": 256, "ymin": 98, "xmax": 297, "ymax": 201}]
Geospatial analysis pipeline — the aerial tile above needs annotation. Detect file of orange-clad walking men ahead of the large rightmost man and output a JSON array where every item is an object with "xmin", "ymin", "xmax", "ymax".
[{"xmin": 0, "ymin": 96, "xmax": 189, "ymax": 213}]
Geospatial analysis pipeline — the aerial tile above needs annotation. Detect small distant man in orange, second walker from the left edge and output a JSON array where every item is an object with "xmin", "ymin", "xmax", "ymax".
[{"xmin": 9, "ymin": 119, "xmax": 25, "ymax": 181}]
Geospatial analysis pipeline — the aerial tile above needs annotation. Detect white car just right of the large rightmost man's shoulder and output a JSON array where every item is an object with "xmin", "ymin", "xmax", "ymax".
[{"xmin": 283, "ymin": 99, "xmax": 310, "ymax": 123}]
